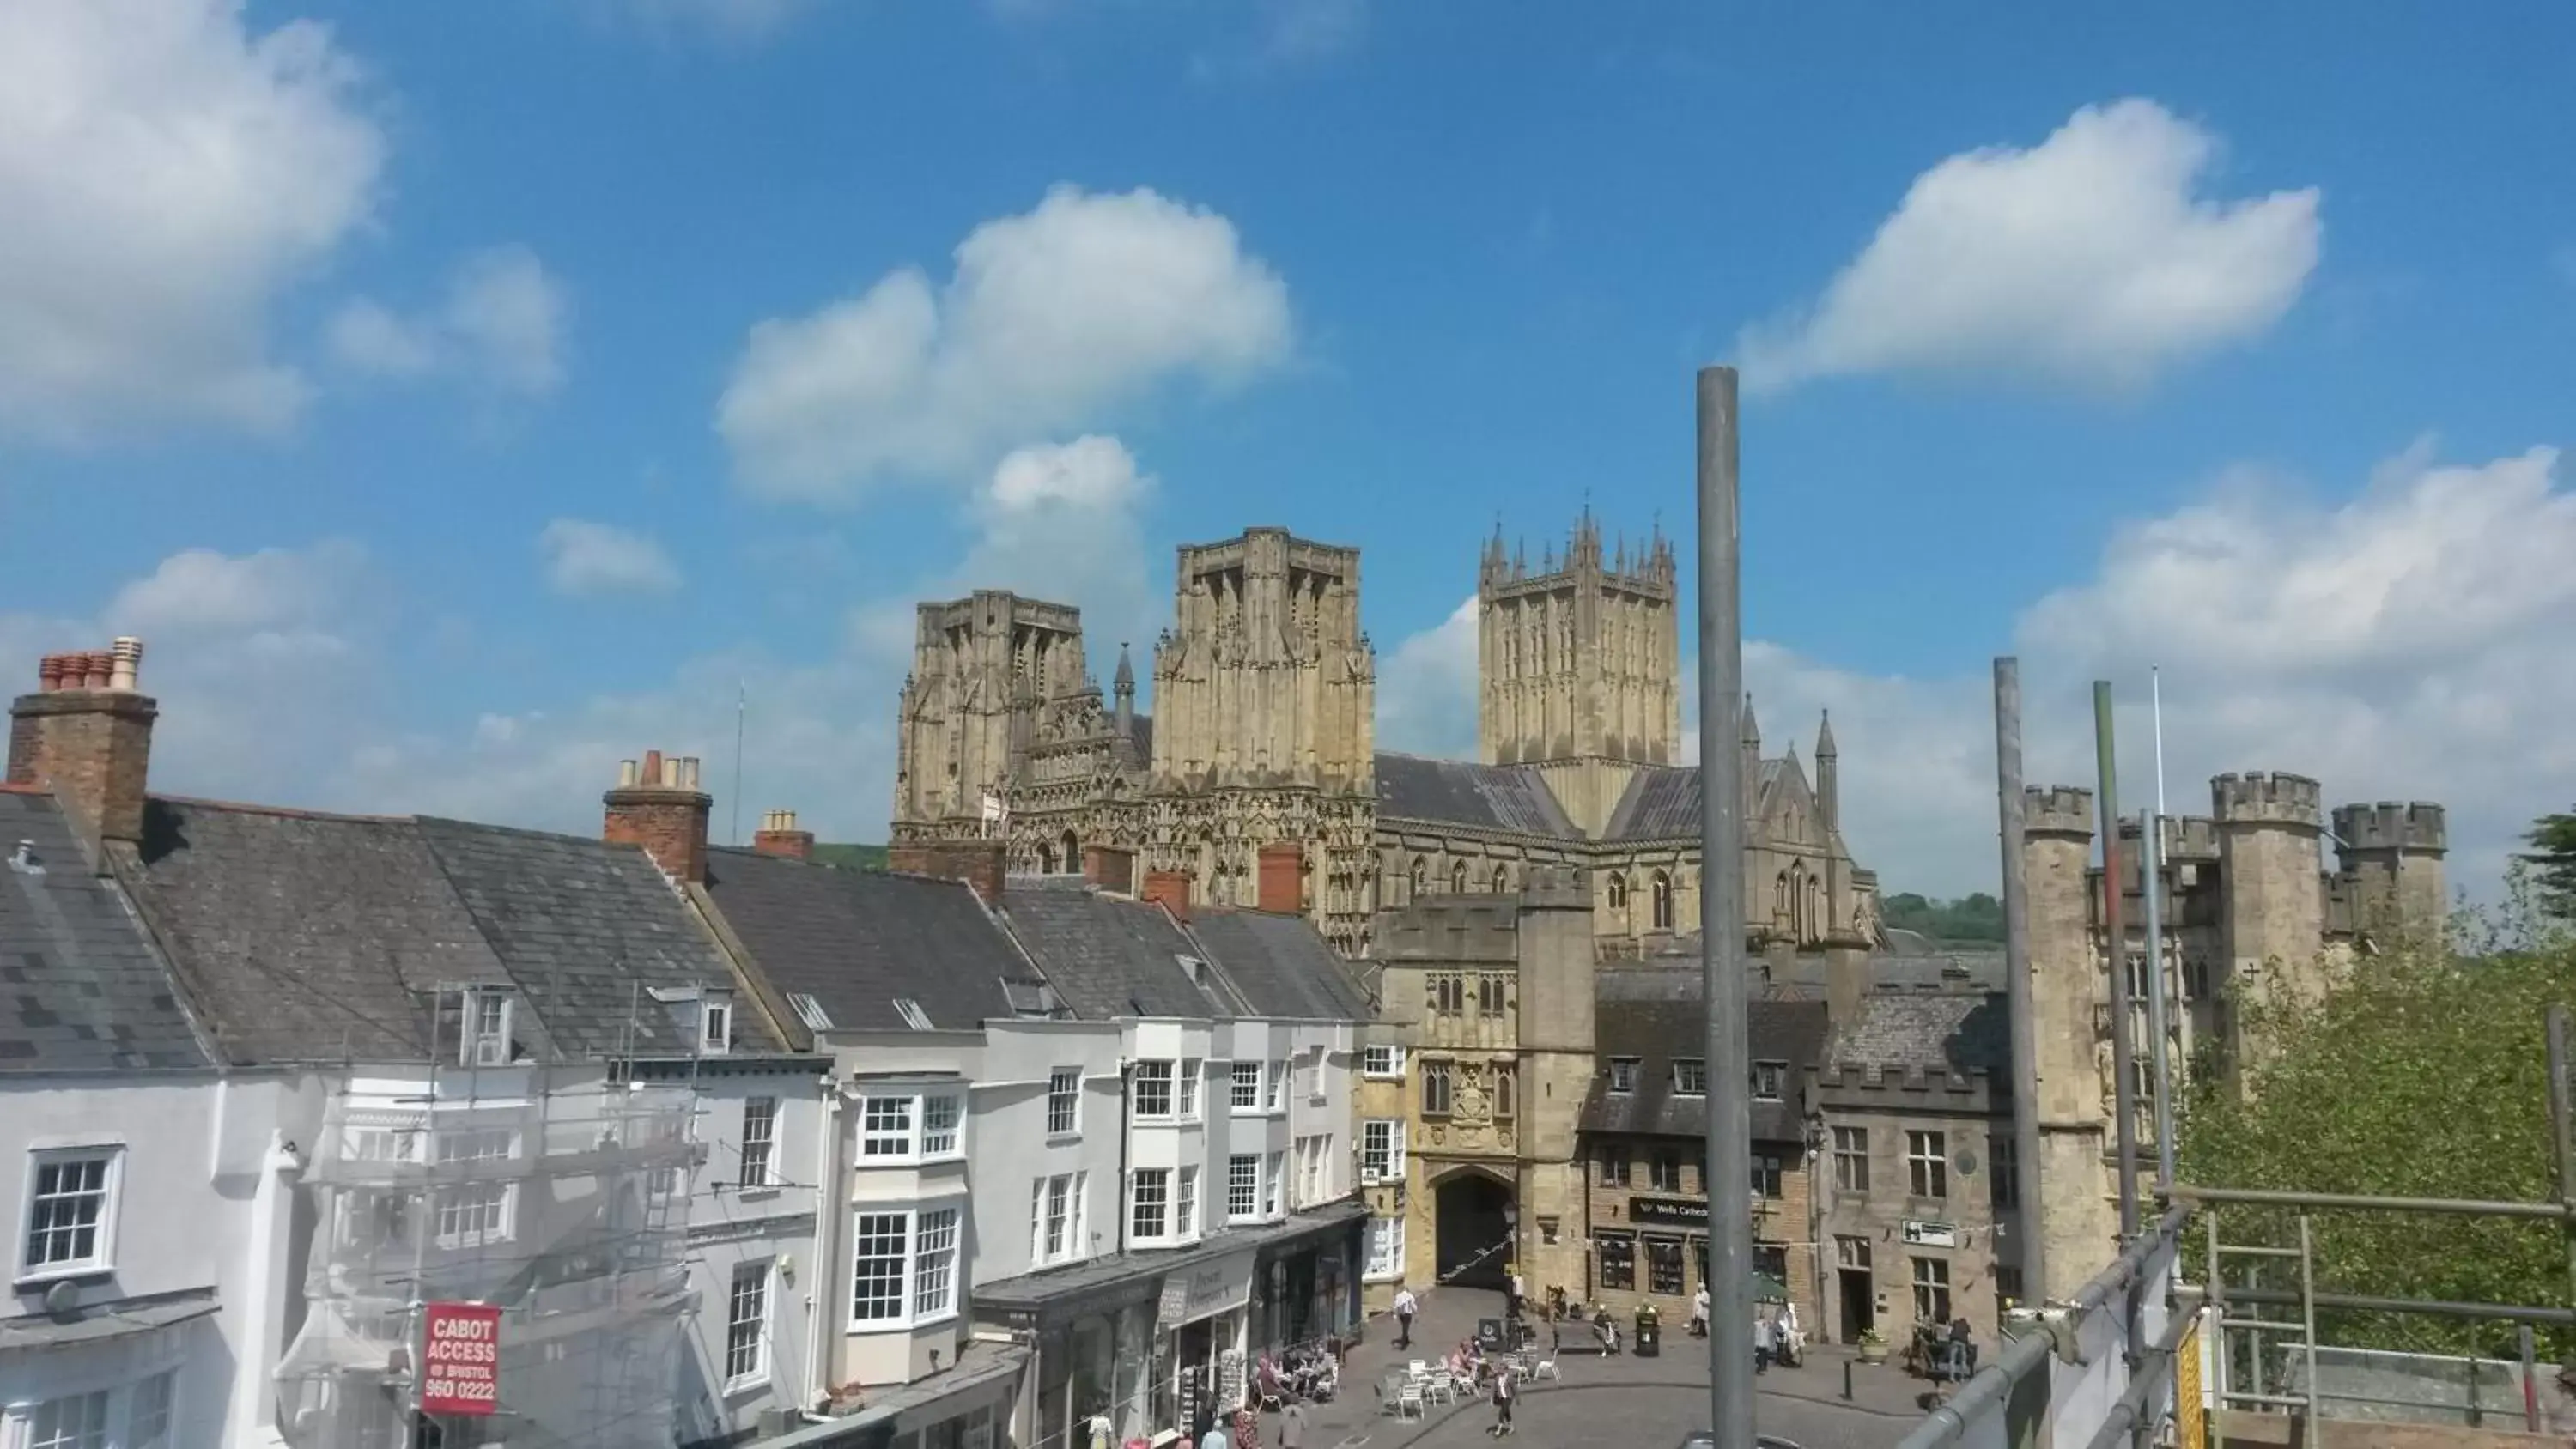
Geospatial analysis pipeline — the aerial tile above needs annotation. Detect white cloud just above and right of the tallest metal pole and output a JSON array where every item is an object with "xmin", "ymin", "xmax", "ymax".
[{"xmin": 1736, "ymin": 100, "xmax": 2324, "ymax": 389}]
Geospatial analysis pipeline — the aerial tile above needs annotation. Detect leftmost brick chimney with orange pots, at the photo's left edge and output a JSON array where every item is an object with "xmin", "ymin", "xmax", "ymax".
[{"xmin": 8, "ymin": 639, "xmax": 160, "ymax": 846}]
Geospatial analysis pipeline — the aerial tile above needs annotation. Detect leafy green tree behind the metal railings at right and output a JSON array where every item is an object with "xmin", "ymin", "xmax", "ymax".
[{"xmin": 2177, "ymin": 895, "xmax": 2576, "ymax": 1356}]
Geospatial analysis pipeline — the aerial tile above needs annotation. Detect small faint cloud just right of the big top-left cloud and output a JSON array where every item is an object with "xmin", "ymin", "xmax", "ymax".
[{"xmin": 325, "ymin": 247, "xmax": 572, "ymax": 397}]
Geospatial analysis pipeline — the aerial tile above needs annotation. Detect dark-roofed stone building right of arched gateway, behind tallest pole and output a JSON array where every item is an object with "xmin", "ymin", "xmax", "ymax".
[{"xmin": 1566, "ymin": 965, "xmax": 1826, "ymax": 1325}]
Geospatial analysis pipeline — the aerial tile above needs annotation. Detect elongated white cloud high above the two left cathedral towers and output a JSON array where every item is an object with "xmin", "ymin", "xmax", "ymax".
[{"xmin": 716, "ymin": 185, "xmax": 1291, "ymax": 502}]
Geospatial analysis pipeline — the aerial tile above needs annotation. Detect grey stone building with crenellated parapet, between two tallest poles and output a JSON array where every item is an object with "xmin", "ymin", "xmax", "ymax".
[{"xmin": 1808, "ymin": 991, "xmax": 2009, "ymax": 1346}]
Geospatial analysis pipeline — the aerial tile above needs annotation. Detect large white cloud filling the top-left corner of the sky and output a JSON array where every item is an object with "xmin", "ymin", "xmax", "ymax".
[{"xmin": 0, "ymin": 0, "xmax": 384, "ymax": 446}]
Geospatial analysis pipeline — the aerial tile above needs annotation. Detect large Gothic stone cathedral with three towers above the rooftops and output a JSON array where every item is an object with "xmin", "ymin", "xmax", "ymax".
[{"xmin": 891, "ymin": 510, "xmax": 1878, "ymax": 957}]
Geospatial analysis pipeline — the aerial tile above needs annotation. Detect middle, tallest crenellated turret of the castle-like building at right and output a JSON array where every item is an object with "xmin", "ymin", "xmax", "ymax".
[{"xmin": 2210, "ymin": 774, "xmax": 2326, "ymax": 1019}]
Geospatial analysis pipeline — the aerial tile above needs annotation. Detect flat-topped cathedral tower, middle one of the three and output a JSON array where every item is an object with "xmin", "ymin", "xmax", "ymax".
[{"xmin": 1154, "ymin": 528, "xmax": 1378, "ymax": 792}]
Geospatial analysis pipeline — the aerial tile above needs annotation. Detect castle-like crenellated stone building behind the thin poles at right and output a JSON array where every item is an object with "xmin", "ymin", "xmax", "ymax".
[{"xmin": 2022, "ymin": 774, "xmax": 2447, "ymax": 1297}]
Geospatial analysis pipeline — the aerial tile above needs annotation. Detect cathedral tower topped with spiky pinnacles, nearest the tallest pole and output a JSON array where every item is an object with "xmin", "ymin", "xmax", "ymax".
[{"xmin": 1476, "ymin": 510, "xmax": 1682, "ymax": 828}]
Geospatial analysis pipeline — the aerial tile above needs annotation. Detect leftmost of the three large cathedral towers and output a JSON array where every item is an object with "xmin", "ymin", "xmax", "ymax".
[{"xmin": 894, "ymin": 590, "xmax": 1092, "ymax": 821}]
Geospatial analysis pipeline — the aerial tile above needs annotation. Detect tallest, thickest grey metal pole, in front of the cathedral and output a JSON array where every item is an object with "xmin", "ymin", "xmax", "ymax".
[{"xmin": 1700, "ymin": 368, "xmax": 1754, "ymax": 1449}]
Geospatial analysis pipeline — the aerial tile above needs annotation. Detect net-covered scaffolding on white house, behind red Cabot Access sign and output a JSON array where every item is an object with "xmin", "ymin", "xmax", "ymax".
[{"xmin": 276, "ymin": 1040, "xmax": 703, "ymax": 1449}]
